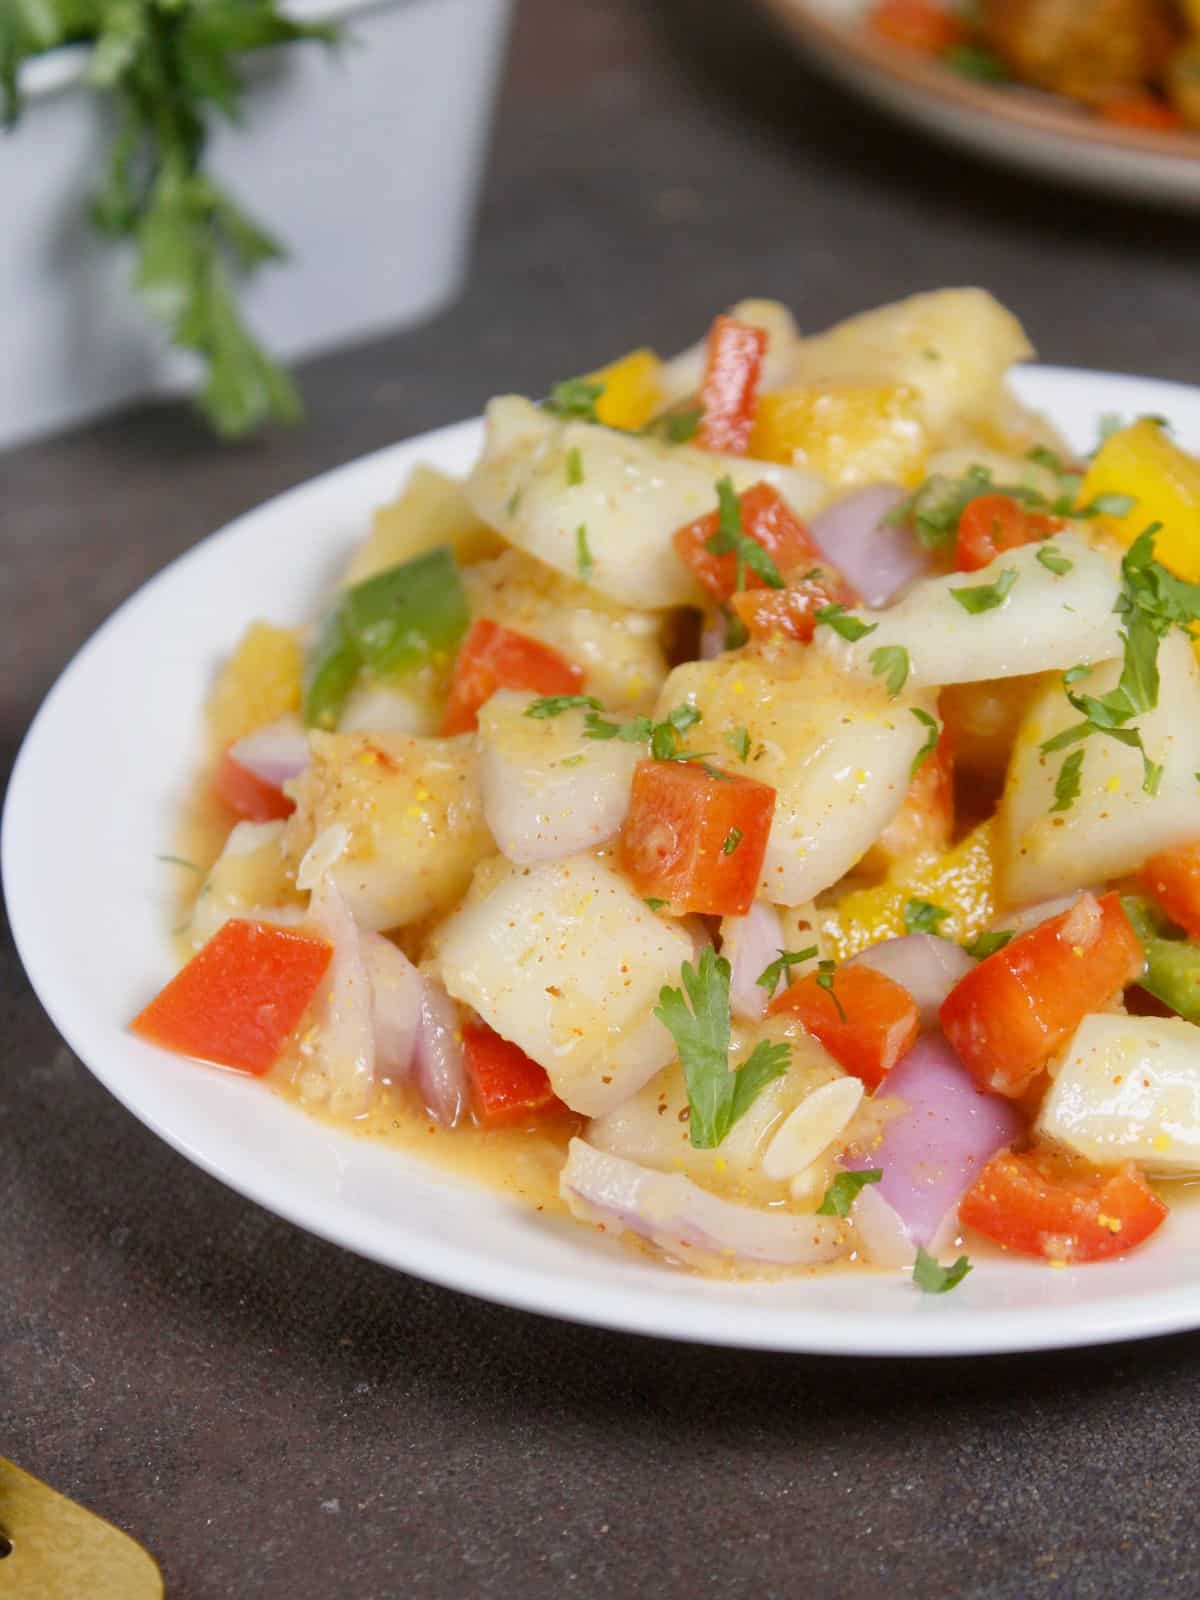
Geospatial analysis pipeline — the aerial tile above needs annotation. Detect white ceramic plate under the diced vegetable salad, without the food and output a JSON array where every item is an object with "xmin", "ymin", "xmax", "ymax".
[{"xmin": 3, "ymin": 368, "xmax": 1200, "ymax": 1355}]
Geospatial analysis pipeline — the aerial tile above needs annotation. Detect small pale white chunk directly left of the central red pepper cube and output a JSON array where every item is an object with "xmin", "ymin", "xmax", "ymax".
[{"xmin": 478, "ymin": 690, "xmax": 646, "ymax": 866}]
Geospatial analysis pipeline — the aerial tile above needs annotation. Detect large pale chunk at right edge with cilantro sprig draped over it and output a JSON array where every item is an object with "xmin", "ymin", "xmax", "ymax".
[{"xmin": 1000, "ymin": 632, "xmax": 1200, "ymax": 906}]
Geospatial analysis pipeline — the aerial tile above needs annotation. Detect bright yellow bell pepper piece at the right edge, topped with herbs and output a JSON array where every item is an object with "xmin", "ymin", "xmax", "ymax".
[{"xmin": 1080, "ymin": 416, "xmax": 1200, "ymax": 582}]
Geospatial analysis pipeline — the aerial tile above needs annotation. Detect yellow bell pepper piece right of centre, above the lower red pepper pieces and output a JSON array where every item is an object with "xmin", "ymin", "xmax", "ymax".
[{"xmin": 818, "ymin": 819, "xmax": 997, "ymax": 962}]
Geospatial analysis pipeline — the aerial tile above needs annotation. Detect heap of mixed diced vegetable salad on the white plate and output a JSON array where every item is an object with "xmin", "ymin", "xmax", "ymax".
[{"xmin": 133, "ymin": 290, "xmax": 1200, "ymax": 1293}]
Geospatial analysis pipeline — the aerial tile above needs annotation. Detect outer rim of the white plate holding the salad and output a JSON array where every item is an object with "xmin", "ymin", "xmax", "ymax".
[{"xmin": 11, "ymin": 365, "xmax": 1200, "ymax": 1358}]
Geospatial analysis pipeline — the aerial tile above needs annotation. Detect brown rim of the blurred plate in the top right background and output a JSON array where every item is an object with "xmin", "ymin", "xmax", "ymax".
[{"xmin": 762, "ymin": 0, "xmax": 1200, "ymax": 162}]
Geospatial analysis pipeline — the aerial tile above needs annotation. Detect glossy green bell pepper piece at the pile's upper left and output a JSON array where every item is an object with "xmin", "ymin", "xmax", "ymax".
[{"xmin": 339, "ymin": 546, "xmax": 470, "ymax": 678}]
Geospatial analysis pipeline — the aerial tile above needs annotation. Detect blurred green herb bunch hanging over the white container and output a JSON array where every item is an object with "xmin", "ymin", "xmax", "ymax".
[{"xmin": 0, "ymin": 0, "xmax": 336, "ymax": 437}]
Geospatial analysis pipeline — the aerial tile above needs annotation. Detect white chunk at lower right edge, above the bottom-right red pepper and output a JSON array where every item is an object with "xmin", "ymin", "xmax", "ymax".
[{"xmin": 1037, "ymin": 1014, "xmax": 1200, "ymax": 1178}]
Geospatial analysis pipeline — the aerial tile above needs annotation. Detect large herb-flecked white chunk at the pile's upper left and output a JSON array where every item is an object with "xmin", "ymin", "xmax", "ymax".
[{"xmin": 467, "ymin": 395, "xmax": 829, "ymax": 611}]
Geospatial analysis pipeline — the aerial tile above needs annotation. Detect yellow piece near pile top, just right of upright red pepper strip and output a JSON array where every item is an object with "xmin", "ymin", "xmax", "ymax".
[{"xmin": 750, "ymin": 384, "xmax": 930, "ymax": 486}]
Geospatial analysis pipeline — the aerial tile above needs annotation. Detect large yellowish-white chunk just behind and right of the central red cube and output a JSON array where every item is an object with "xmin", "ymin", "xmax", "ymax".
[{"xmin": 658, "ymin": 650, "xmax": 931, "ymax": 906}]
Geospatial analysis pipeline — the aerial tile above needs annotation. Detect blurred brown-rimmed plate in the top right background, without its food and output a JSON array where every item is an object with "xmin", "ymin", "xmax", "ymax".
[{"xmin": 763, "ymin": 0, "xmax": 1200, "ymax": 211}]
